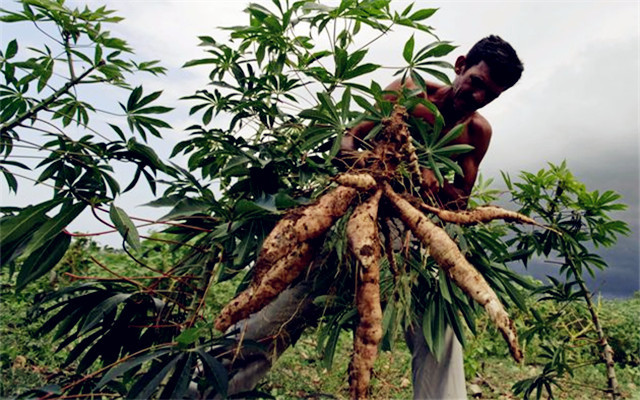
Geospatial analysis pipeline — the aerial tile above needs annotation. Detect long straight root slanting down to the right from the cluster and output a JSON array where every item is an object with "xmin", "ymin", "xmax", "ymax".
[{"xmin": 385, "ymin": 185, "xmax": 522, "ymax": 361}]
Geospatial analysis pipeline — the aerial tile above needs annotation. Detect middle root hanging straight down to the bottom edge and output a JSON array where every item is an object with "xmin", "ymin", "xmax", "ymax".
[{"xmin": 347, "ymin": 190, "xmax": 382, "ymax": 399}]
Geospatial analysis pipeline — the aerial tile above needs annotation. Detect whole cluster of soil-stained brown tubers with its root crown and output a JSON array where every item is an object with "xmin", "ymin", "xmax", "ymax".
[{"xmin": 215, "ymin": 105, "xmax": 535, "ymax": 399}]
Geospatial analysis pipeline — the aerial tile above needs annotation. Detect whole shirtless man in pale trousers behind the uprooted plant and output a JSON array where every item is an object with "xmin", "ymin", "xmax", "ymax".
[{"xmin": 212, "ymin": 36, "xmax": 523, "ymax": 399}]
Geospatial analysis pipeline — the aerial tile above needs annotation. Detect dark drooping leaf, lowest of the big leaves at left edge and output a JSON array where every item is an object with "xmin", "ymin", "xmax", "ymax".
[{"xmin": 16, "ymin": 233, "xmax": 71, "ymax": 291}]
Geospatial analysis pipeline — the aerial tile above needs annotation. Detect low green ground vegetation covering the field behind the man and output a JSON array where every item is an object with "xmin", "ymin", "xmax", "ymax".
[{"xmin": 0, "ymin": 245, "xmax": 640, "ymax": 400}]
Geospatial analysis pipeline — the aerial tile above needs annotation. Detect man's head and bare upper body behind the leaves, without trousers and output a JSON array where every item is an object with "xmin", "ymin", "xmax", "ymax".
[{"xmin": 342, "ymin": 35, "xmax": 523, "ymax": 208}]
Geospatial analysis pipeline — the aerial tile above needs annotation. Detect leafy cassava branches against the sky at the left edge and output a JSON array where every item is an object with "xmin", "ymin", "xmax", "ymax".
[{"xmin": 0, "ymin": 0, "xmax": 174, "ymax": 289}]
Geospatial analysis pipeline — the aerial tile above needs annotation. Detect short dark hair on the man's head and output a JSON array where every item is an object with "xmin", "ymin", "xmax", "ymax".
[{"xmin": 465, "ymin": 35, "xmax": 524, "ymax": 88}]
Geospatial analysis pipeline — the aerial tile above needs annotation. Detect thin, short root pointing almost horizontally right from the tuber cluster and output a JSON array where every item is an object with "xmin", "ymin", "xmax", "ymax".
[{"xmin": 420, "ymin": 203, "xmax": 540, "ymax": 226}]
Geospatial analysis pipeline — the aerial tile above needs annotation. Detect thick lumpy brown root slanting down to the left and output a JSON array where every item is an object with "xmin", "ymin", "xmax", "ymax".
[{"xmin": 215, "ymin": 186, "xmax": 357, "ymax": 332}]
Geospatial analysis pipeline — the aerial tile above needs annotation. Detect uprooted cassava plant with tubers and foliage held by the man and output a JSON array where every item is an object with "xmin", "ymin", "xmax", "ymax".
[{"xmin": 171, "ymin": 1, "xmax": 544, "ymax": 398}]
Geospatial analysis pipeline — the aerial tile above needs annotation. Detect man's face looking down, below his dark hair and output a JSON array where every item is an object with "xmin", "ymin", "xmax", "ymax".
[{"xmin": 452, "ymin": 57, "xmax": 507, "ymax": 114}]
